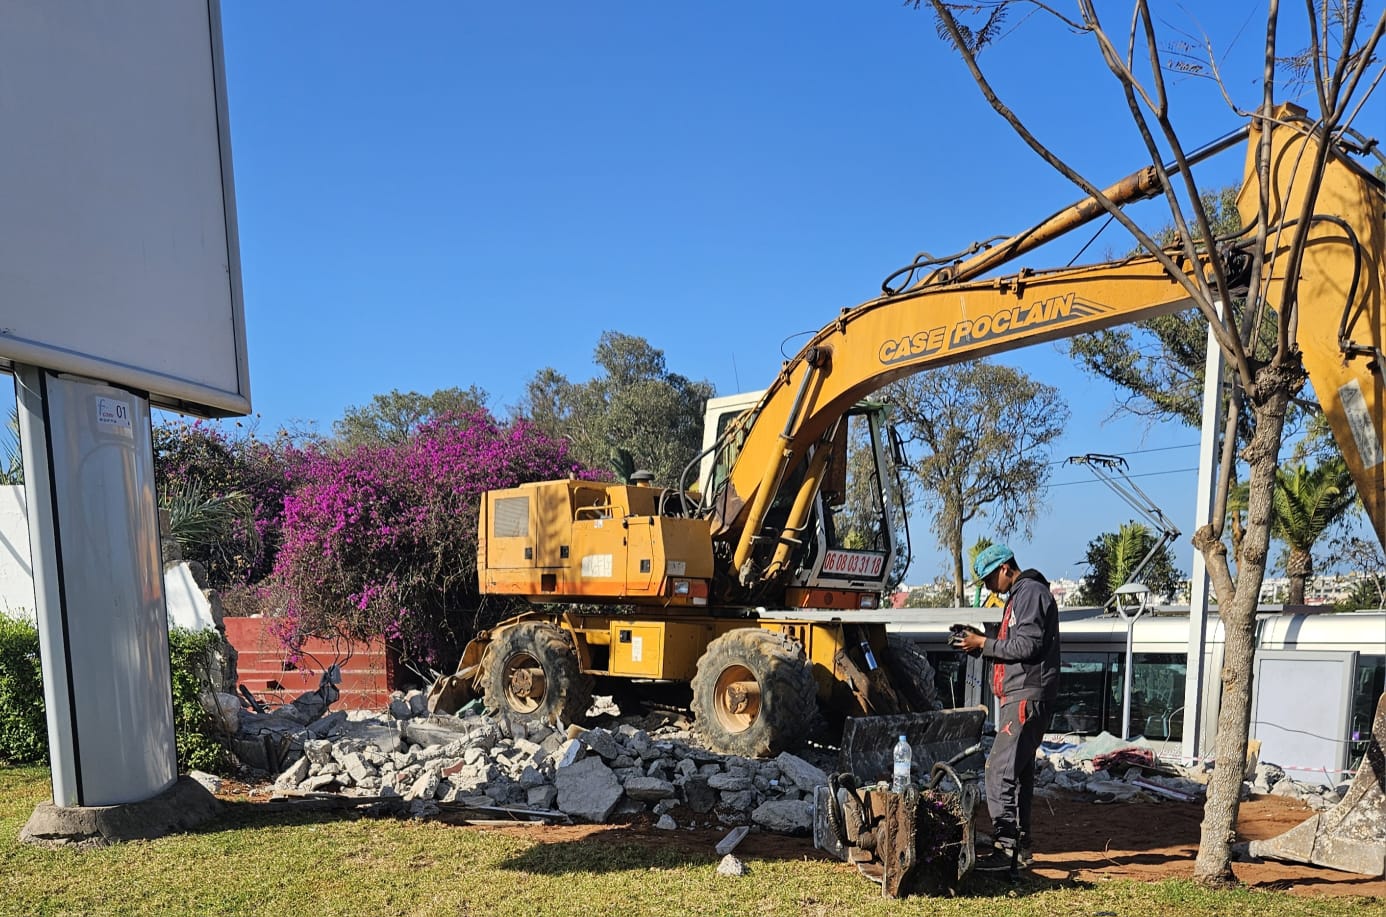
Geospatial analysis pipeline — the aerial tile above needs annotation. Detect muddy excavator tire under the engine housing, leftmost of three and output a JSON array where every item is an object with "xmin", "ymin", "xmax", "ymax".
[{"xmin": 482, "ymin": 621, "xmax": 592, "ymax": 724}]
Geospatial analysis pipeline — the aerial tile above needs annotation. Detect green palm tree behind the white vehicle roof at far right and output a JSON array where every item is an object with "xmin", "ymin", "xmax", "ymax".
[{"xmin": 1229, "ymin": 454, "xmax": 1357, "ymax": 605}]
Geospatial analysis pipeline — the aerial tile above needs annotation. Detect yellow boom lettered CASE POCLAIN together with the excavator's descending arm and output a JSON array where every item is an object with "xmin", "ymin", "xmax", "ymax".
[{"xmin": 712, "ymin": 112, "xmax": 1383, "ymax": 582}]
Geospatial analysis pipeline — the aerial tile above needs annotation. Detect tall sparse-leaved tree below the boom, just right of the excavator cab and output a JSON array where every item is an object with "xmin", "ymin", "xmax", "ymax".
[{"xmin": 886, "ymin": 360, "xmax": 1069, "ymax": 605}]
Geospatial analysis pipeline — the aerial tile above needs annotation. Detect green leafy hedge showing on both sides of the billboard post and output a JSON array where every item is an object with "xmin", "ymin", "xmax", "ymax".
[{"xmin": 0, "ymin": 615, "xmax": 230, "ymax": 772}]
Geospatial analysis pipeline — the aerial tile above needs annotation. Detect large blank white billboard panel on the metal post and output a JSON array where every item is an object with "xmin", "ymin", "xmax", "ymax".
[{"xmin": 0, "ymin": 0, "xmax": 251, "ymax": 416}]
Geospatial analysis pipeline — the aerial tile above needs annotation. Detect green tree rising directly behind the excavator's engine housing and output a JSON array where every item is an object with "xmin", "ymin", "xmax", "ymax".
[{"xmin": 518, "ymin": 331, "xmax": 715, "ymax": 485}]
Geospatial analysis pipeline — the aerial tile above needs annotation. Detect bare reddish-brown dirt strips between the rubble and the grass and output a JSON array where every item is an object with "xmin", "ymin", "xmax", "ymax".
[{"xmin": 468, "ymin": 796, "xmax": 1386, "ymax": 898}]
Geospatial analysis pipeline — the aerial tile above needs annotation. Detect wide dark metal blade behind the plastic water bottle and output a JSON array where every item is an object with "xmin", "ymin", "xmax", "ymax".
[{"xmin": 837, "ymin": 706, "xmax": 988, "ymax": 784}]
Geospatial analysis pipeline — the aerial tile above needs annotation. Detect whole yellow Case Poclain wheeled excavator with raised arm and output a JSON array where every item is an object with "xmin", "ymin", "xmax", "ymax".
[{"xmin": 431, "ymin": 107, "xmax": 1386, "ymax": 778}]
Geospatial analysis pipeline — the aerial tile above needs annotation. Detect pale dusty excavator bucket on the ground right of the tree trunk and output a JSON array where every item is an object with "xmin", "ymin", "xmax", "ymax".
[{"xmin": 1247, "ymin": 694, "xmax": 1386, "ymax": 875}]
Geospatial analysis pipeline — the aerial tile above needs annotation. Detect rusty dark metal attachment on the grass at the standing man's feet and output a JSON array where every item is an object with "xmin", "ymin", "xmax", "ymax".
[{"xmin": 814, "ymin": 749, "xmax": 979, "ymax": 898}]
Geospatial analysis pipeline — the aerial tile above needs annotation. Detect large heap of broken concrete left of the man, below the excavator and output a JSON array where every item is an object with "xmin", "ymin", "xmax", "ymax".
[{"xmin": 225, "ymin": 691, "xmax": 827, "ymax": 834}]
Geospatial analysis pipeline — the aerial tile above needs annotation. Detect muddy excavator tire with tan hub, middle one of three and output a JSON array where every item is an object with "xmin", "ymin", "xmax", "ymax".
[{"xmin": 693, "ymin": 627, "xmax": 818, "ymax": 758}]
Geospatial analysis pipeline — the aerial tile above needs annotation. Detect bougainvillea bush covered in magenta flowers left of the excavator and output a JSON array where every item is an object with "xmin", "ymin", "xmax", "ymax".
[{"xmin": 274, "ymin": 411, "xmax": 593, "ymax": 666}]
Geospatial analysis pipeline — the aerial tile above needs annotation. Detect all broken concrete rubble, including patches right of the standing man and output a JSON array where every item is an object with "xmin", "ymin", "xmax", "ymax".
[{"xmin": 216, "ymin": 680, "xmax": 1346, "ymax": 834}]
